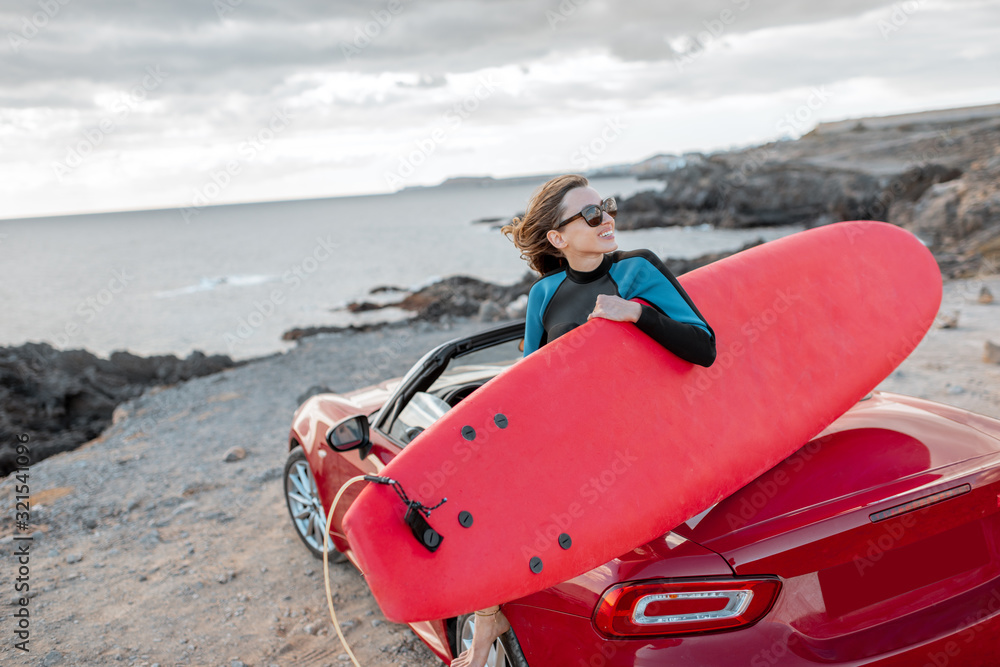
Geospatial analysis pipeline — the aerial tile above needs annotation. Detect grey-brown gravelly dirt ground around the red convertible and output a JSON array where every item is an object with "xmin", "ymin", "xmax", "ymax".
[{"xmin": 0, "ymin": 277, "xmax": 1000, "ymax": 667}]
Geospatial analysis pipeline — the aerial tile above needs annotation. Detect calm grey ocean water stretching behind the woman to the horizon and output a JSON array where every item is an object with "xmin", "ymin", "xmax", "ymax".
[{"xmin": 0, "ymin": 178, "xmax": 795, "ymax": 359}]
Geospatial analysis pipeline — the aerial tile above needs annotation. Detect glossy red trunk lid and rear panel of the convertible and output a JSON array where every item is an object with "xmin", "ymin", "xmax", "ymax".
[{"xmin": 678, "ymin": 395, "xmax": 1000, "ymax": 662}]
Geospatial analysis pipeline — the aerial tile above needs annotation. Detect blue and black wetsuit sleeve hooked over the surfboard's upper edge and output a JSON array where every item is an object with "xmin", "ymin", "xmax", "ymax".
[{"xmin": 624, "ymin": 251, "xmax": 715, "ymax": 366}]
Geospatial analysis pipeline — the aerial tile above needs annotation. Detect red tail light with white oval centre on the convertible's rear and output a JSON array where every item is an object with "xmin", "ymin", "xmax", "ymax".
[{"xmin": 594, "ymin": 578, "xmax": 781, "ymax": 637}]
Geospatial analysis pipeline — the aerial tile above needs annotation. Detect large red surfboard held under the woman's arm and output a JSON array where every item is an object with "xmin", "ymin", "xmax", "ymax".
[{"xmin": 344, "ymin": 221, "xmax": 941, "ymax": 622}]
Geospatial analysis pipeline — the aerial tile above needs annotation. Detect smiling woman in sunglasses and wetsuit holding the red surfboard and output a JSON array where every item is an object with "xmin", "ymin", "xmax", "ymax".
[{"xmin": 452, "ymin": 175, "xmax": 715, "ymax": 667}]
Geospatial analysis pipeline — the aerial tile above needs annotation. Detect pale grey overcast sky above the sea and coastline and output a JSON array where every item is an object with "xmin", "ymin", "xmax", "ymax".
[{"xmin": 0, "ymin": 0, "xmax": 1000, "ymax": 218}]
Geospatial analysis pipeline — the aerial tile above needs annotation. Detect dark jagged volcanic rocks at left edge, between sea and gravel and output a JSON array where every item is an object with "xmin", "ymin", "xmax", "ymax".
[{"xmin": 0, "ymin": 343, "xmax": 238, "ymax": 475}]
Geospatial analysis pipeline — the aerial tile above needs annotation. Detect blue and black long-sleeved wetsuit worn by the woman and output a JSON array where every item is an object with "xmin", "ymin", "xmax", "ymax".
[{"xmin": 524, "ymin": 250, "xmax": 715, "ymax": 366}]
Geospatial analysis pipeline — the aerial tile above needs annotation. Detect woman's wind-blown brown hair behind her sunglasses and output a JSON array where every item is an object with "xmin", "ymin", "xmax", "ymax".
[{"xmin": 500, "ymin": 174, "xmax": 590, "ymax": 275}]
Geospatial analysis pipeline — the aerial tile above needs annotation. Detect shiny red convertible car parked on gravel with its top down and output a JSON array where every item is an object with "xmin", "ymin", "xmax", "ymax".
[{"xmin": 284, "ymin": 323, "xmax": 1000, "ymax": 667}]
